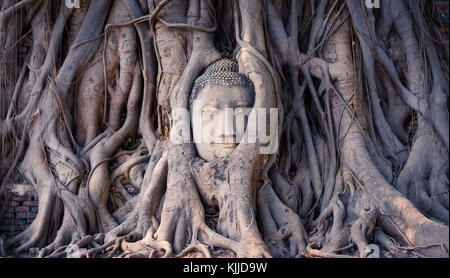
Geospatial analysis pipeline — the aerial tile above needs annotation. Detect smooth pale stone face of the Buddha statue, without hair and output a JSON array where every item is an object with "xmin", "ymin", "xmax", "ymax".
[{"xmin": 191, "ymin": 85, "xmax": 254, "ymax": 161}]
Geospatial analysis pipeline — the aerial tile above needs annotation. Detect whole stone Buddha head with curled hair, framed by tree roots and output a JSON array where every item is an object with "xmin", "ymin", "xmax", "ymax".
[{"xmin": 189, "ymin": 59, "xmax": 255, "ymax": 161}]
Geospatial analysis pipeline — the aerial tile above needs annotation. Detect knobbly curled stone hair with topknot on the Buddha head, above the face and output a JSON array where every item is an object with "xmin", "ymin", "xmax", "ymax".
[{"xmin": 189, "ymin": 58, "xmax": 255, "ymax": 109}]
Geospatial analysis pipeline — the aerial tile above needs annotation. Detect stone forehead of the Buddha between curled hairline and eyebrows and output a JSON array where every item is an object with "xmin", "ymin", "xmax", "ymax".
[{"xmin": 193, "ymin": 84, "xmax": 254, "ymax": 109}]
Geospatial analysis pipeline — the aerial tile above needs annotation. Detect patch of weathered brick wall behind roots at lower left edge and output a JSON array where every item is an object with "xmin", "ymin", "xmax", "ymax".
[{"xmin": 0, "ymin": 184, "xmax": 38, "ymax": 237}]
